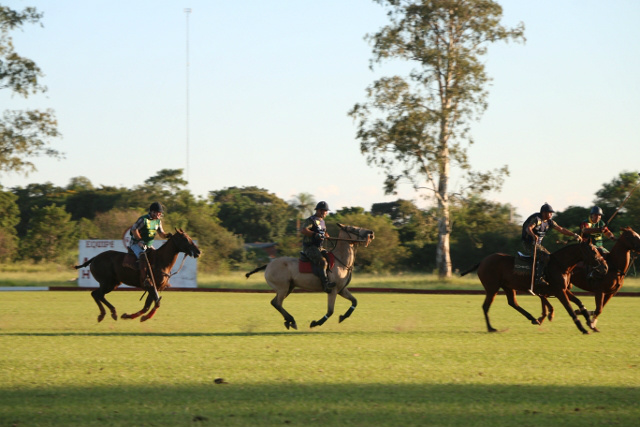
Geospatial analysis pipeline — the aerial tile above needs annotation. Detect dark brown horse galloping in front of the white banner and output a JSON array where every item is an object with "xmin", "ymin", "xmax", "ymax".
[{"xmin": 75, "ymin": 229, "xmax": 201, "ymax": 322}]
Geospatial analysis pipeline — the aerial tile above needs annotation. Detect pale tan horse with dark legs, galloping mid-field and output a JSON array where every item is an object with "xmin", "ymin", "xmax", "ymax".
[{"xmin": 245, "ymin": 224, "xmax": 375, "ymax": 329}]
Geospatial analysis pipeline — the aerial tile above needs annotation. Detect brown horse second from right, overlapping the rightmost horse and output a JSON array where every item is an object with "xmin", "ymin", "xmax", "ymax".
[{"xmin": 460, "ymin": 242, "xmax": 607, "ymax": 334}]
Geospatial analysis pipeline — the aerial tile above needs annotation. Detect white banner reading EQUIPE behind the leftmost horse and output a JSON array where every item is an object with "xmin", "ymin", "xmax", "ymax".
[{"xmin": 78, "ymin": 238, "xmax": 198, "ymax": 288}]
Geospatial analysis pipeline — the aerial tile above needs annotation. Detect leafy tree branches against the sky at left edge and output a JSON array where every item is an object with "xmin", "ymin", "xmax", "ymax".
[{"xmin": 0, "ymin": 5, "xmax": 62, "ymax": 173}]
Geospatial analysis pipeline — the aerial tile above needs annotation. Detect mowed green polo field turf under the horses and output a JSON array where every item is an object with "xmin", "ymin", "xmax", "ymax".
[{"xmin": 0, "ymin": 291, "xmax": 640, "ymax": 427}]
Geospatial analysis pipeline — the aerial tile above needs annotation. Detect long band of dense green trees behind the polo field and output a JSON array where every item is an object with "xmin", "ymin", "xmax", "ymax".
[{"xmin": 0, "ymin": 169, "xmax": 640, "ymax": 273}]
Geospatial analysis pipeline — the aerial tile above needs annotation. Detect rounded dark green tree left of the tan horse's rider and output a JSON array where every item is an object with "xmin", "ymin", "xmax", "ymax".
[{"xmin": 211, "ymin": 187, "xmax": 296, "ymax": 243}]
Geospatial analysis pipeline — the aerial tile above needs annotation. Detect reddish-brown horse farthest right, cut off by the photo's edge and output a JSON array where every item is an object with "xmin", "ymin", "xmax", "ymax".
[{"xmin": 540, "ymin": 227, "xmax": 640, "ymax": 332}]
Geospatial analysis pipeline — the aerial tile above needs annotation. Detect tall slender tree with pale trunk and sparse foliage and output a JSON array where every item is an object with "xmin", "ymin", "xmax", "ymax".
[{"xmin": 349, "ymin": 0, "xmax": 524, "ymax": 277}]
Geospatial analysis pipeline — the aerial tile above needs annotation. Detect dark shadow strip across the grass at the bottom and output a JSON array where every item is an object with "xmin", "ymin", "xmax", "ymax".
[{"xmin": 0, "ymin": 379, "xmax": 640, "ymax": 427}]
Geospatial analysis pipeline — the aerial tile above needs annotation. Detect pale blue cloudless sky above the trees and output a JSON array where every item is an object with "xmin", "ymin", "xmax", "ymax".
[{"xmin": 0, "ymin": 0, "xmax": 640, "ymax": 218}]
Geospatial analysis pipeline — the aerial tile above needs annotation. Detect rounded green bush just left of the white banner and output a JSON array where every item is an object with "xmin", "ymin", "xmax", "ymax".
[{"xmin": 20, "ymin": 205, "xmax": 78, "ymax": 262}]
